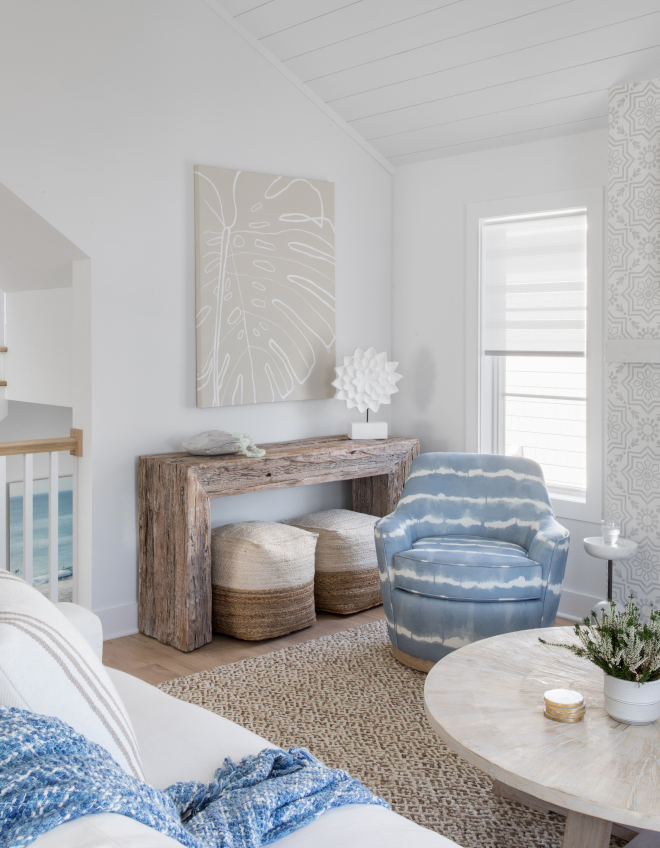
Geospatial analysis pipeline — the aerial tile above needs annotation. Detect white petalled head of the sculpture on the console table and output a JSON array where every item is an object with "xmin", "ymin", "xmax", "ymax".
[{"xmin": 331, "ymin": 347, "xmax": 403, "ymax": 416}]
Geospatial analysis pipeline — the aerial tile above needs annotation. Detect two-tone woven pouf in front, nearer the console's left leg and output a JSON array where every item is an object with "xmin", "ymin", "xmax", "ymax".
[{"xmin": 211, "ymin": 521, "xmax": 316, "ymax": 641}]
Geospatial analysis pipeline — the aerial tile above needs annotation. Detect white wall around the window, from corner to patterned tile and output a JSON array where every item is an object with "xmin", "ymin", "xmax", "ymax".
[{"xmin": 392, "ymin": 130, "xmax": 608, "ymax": 616}]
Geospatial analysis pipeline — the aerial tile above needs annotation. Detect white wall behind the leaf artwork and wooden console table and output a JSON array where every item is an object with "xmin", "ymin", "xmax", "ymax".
[{"xmin": 0, "ymin": 0, "xmax": 391, "ymax": 635}]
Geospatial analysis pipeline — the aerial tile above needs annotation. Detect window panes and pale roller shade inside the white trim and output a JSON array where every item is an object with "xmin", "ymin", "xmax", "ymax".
[{"xmin": 481, "ymin": 209, "xmax": 587, "ymax": 500}]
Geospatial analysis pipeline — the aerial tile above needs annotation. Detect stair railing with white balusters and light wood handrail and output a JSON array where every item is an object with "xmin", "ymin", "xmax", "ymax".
[{"xmin": 0, "ymin": 429, "xmax": 83, "ymax": 603}]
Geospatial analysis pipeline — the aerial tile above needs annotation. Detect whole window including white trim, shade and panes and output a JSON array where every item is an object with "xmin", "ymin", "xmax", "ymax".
[{"xmin": 467, "ymin": 190, "xmax": 603, "ymax": 520}]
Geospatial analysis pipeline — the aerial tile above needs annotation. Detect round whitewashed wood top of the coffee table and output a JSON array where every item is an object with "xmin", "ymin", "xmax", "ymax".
[{"xmin": 424, "ymin": 627, "xmax": 660, "ymax": 830}]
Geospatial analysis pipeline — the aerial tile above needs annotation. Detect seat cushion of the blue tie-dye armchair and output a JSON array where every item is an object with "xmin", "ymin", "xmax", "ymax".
[{"xmin": 392, "ymin": 536, "xmax": 545, "ymax": 601}]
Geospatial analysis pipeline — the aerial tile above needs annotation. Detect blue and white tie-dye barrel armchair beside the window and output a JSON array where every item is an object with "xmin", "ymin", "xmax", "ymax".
[{"xmin": 375, "ymin": 453, "xmax": 570, "ymax": 670}]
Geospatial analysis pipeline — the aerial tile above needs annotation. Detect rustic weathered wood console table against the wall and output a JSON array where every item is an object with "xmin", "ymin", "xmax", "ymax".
[{"xmin": 138, "ymin": 436, "xmax": 419, "ymax": 651}]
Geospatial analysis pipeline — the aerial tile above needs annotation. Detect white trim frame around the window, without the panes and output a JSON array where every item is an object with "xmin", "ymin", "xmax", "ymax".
[{"xmin": 465, "ymin": 186, "xmax": 605, "ymax": 522}]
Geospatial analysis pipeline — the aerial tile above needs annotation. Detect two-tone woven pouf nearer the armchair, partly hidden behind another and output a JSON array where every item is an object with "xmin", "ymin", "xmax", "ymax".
[{"xmin": 286, "ymin": 509, "xmax": 383, "ymax": 615}]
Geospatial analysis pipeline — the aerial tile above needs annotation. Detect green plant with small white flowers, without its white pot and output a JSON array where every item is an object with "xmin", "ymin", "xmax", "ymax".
[{"xmin": 539, "ymin": 595, "xmax": 660, "ymax": 683}]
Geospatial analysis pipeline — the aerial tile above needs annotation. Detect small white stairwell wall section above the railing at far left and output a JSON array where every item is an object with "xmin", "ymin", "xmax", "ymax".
[{"xmin": 5, "ymin": 287, "xmax": 73, "ymax": 408}]
